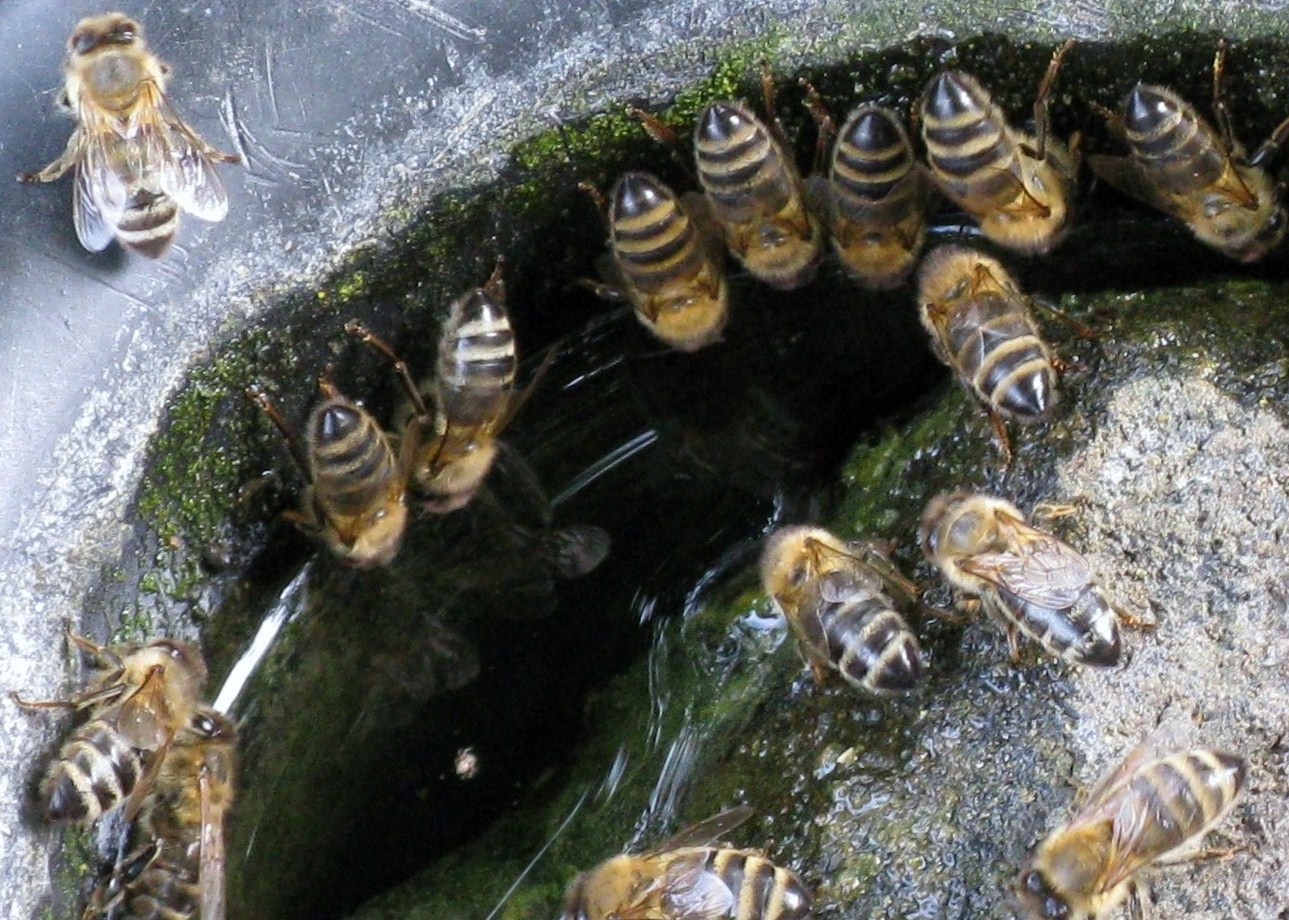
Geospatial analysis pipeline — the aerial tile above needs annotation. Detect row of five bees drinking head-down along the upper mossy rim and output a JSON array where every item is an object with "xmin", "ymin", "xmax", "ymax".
[{"xmin": 588, "ymin": 41, "xmax": 1289, "ymax": 350}]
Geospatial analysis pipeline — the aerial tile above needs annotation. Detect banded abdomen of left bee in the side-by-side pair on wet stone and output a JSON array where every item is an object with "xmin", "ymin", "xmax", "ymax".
[{"xmin": 821, "ymin": 598, "xmax": 922, "ymax": 693}]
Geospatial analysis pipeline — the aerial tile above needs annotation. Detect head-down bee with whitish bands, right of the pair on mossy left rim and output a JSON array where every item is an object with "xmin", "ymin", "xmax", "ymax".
[{"xmin": 348, "ymin": 260, "xmax": 541, "ymax": 514}]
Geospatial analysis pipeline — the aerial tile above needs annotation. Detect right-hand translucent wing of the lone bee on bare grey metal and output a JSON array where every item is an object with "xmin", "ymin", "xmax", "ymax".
[{"xmin": 148, "ymin": 86, "xmax": 228, "ymax": 222}]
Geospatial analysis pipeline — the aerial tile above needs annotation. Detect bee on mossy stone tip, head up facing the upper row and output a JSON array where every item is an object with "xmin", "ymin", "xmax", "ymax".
[{"xmin": 918, "ymin": 246, "xmax": 1058, "ymax": 468}]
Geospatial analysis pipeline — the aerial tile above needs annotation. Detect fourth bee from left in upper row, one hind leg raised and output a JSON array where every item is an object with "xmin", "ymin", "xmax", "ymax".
[{"xmin": 922, "ymin": 41, "xmax": 1079, "ymax": 255}]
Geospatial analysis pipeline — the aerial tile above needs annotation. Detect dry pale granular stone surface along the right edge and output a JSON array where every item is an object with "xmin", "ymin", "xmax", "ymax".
[{"xmin": 1049, "ymin": 378, "xmax": 1289, "ymax": 920}]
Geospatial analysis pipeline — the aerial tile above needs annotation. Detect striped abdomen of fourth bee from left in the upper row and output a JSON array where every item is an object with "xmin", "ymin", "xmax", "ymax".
[{"xmin": 922, "ymin": 71, "xmax": 1014, "ymax": 200}]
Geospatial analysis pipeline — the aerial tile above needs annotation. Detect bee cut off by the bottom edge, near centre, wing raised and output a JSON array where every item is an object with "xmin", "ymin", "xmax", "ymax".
[{"xmin": 561, "ymin": 808, "xmax": 811, "ymax": 920}]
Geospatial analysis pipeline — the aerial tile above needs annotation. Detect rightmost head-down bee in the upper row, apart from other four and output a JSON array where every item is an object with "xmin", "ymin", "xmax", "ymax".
[{"xmin": 1088, "ymin": 44, "xmax": 1289, "ymax": 263}]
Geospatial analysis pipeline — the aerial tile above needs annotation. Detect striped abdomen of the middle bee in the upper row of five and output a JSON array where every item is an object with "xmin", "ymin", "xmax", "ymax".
[{"xmin": 833, "ymin": 104, "xmax": 913, "ymax": 204}]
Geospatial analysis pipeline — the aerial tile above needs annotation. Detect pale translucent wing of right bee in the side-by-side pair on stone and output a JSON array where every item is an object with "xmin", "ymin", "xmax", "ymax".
[{"xmin": 959, "ymin": 518, "xmax": 1092, "ymax": 609}]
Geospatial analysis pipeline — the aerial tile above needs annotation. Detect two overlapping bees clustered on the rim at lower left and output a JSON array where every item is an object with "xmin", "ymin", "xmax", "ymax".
[{"xmin": 10, "ymin": 630, "xmax": 237, "ymax": 920}]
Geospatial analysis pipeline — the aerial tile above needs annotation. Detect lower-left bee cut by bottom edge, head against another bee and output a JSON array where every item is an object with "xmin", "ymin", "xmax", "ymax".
[{"xmin": 94, "ymin": 706, "xmax": 237, "ymax": 920}]
